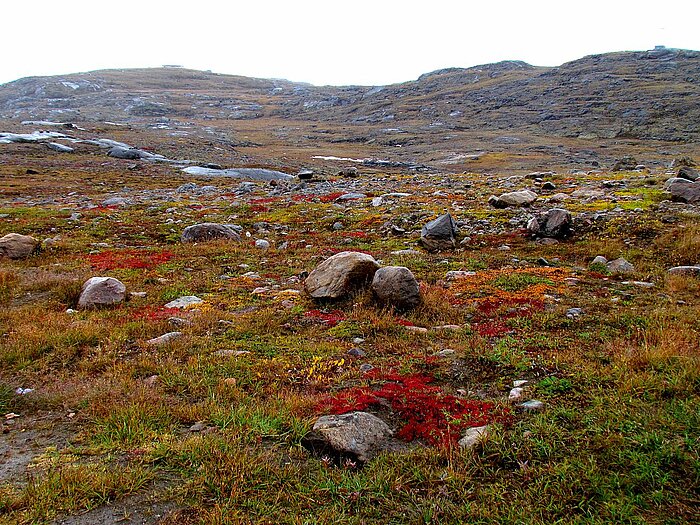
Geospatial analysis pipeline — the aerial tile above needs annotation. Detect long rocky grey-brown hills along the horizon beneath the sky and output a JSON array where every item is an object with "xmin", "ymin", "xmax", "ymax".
[{"xmin": 0, "ymin": 48, "xmax": 700, "ymax": 141}]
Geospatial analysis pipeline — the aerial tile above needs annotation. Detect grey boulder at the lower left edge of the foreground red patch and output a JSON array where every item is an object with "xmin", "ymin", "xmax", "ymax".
[{"xmin": 304, "ymin": 412, "xmax": 392, "ymax": 462}]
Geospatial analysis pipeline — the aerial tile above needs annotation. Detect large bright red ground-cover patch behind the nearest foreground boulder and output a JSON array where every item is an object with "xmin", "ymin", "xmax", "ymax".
[{"xmin": 319, "ymin": 373, "xmax": 510, "ymax": 447}]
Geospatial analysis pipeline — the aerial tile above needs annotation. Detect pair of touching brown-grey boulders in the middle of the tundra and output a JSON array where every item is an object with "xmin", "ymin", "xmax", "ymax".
[{"xmin": 304, "ymin": 252, "xmax": 421, "ymax": 310}]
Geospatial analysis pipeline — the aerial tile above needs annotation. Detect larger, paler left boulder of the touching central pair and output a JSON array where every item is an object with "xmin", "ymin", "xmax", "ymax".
[{"xmin": 304, "ymin": 252, "xmax": 379, "ymax": 299}]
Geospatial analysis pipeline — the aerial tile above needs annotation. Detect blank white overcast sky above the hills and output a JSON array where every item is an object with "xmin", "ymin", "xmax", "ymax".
[{"xmin": 0, "ymin": 0, "xmax": 700, "ymax": 85}]
